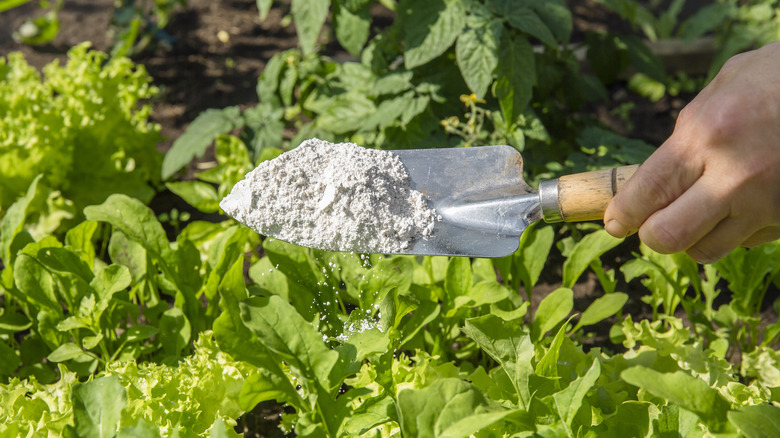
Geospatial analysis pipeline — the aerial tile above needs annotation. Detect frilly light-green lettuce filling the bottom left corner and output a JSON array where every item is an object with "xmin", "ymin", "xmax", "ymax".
[{"xmin": 0, "ymin": 333, "xmax": 254, "ymax": 438}]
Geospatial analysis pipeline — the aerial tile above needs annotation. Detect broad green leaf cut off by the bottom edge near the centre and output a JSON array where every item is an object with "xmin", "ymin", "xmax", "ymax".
[{"xmin": 397, "ymin": 378, "xmax": 514, "ymax": 438}]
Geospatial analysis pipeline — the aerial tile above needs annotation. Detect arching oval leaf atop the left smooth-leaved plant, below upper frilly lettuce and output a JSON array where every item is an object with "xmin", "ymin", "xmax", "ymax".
[{"xmin": 84, "ymin": 194, "xmax": 170, "ymax": 256}]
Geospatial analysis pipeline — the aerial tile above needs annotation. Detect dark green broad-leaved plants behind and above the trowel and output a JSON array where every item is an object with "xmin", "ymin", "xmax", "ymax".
[{"xmin": 162, "ymin": 0, "xmax": 652, "ymax": 183}]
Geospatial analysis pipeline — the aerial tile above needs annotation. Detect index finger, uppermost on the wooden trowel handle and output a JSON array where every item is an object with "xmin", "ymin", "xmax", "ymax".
[{"xmin": 604, "ymin": 136, "xmax": 703, "ymax": 237}]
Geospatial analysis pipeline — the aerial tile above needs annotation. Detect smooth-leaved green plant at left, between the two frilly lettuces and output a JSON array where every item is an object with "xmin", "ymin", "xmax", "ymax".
[{"xmin": 0, "ymin": 177, "xmax": 251, "ymax": 382}]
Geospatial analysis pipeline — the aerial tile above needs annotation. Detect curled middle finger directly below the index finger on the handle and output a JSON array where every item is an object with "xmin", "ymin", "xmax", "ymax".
[{"xmin": 639, "ymin": 175, "xmax": 732, "ymax": 254}]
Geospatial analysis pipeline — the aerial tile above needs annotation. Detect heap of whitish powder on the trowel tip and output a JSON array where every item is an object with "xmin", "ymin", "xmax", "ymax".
[{"xmin": 219, "ymin": 138, "xmax": 436, "ymax": 253}]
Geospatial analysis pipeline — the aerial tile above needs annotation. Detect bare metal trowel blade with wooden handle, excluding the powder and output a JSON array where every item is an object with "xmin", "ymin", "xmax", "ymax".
[{"xmin": 392, "ymin": 146, "xmax": 639, "ymax": 257}]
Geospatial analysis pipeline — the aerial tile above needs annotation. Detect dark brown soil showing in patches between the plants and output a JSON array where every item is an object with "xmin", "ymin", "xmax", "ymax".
[{"xmin": 0, "ymin": 0, "xmax": 780, "ymax": 437}]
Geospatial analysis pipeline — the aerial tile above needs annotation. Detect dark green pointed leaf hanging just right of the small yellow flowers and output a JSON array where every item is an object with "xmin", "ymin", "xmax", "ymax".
[{"xmin": 493, "ymin": 32, "xmax": 536, "ymax": 126}]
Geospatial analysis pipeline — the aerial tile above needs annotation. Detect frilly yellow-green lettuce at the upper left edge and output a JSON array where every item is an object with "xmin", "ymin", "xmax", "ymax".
[{"xmin": 0, "ymin": 44, "xmax": 161, "ymax": 235}]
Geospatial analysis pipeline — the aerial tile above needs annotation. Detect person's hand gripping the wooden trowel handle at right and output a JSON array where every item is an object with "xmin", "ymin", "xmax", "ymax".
[{"xmin": 604, "ymin": 42, "xmax": 780, "ymax": 263}]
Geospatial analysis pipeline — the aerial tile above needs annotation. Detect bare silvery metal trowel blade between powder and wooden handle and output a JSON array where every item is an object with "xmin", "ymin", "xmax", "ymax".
[{"xmin": 392, "ymin": 145, "xmax": 541, "ymax": 257}]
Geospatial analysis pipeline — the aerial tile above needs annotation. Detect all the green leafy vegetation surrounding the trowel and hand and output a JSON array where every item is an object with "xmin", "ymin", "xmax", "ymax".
[{"xmin": 0, "ymin": 0, "xmax": 780, "ymax": 438}]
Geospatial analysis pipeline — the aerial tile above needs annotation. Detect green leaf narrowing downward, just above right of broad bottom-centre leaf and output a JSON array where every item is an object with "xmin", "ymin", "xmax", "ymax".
[{"xmin": 463, "ymin": 314, "xmax": 534, "ymax": 407}]
